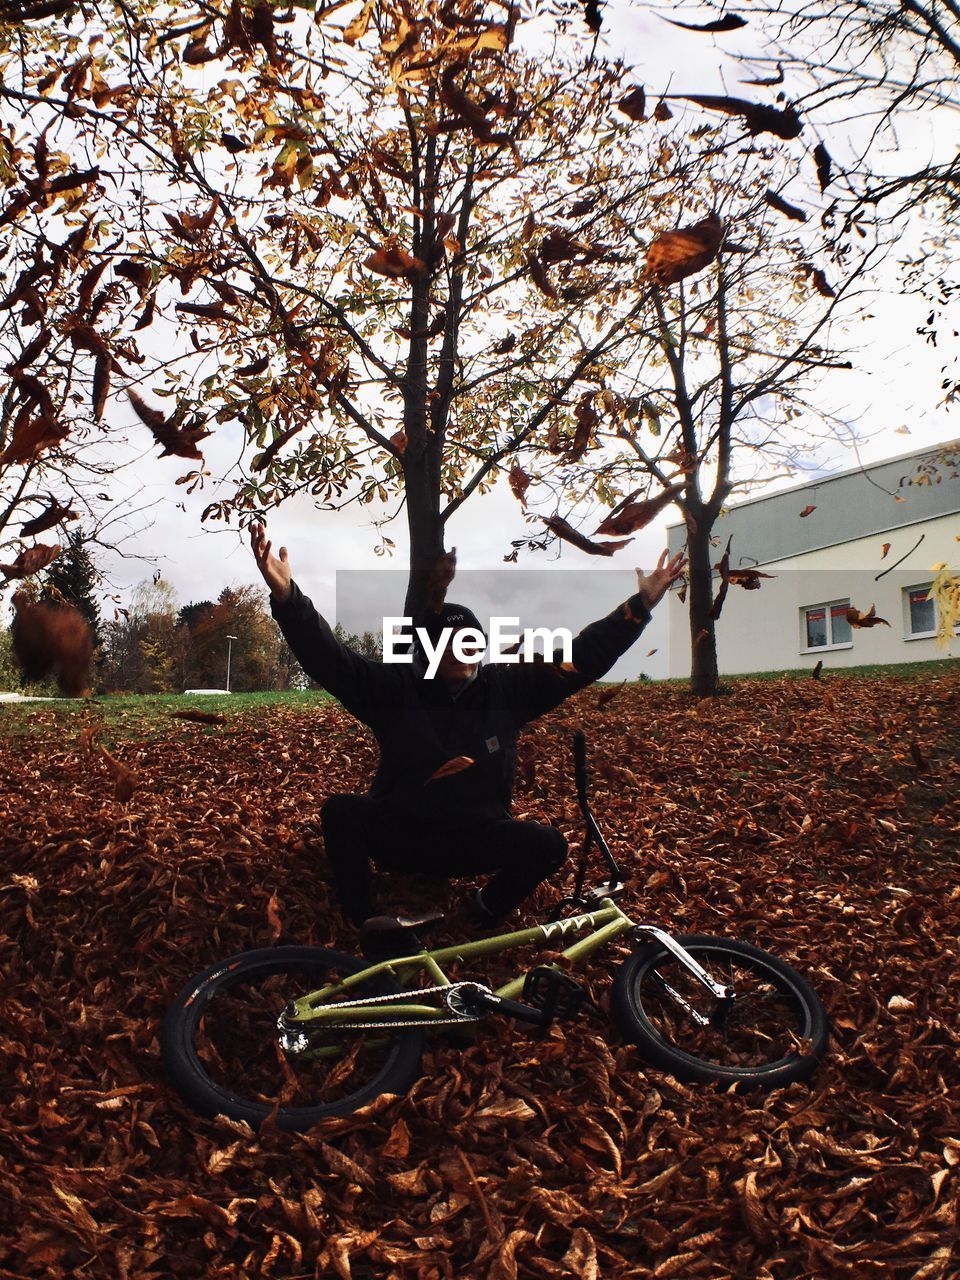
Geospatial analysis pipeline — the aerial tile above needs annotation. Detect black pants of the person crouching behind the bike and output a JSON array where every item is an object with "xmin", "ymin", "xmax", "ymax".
[{"xmin": 320, "ymin": 795, "xmax": 567, "ymax": 924}]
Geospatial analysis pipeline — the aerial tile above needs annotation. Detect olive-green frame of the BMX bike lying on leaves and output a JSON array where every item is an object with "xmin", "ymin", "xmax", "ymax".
[{"xmin": 284, "ymin": 897, "xmax": 634, "ymax": 1030}]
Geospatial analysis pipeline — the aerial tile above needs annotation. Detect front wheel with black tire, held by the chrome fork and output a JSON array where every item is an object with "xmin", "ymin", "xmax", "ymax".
[{"xmin": 612, "ymin": 933, "xmax": 828, "ymax": 1089}]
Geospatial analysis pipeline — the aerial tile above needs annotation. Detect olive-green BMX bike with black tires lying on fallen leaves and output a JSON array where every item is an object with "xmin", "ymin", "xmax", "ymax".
[{"xmin": 160, "ymin": 732, "xmax": 828, "ymax": 1130}]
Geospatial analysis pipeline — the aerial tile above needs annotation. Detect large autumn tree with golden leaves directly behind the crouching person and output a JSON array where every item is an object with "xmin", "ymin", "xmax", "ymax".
[{"xmin": 0, "ymin": 0, "xmax": 682, "ymax": 612}]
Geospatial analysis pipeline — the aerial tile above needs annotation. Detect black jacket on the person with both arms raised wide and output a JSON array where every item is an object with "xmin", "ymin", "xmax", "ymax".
[{"xmin": 271, "ymin": 582, "xmax": 650, "ymax": 827}]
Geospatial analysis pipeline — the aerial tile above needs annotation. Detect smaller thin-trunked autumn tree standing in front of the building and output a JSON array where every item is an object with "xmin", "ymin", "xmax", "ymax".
[{"xmin": 508, "ymin": 143, "xmax": 879, "ymax": 696}]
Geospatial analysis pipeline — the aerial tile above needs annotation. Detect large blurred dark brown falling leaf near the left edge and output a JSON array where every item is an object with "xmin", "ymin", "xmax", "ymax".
[{"xmin": 10, "ymin": 591, "xmax": 93, "ymax": 698}]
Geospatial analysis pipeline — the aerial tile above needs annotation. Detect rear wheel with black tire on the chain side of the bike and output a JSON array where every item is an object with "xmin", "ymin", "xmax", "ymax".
[{"xmin": 160, "ymin": 947, "xmax": 424, "ymax": 1132}]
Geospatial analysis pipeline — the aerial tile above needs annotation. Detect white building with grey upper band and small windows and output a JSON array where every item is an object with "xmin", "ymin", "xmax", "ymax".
[{"xmin": 667, "ymin": 442, "xmax": 960, "ymax": 677}]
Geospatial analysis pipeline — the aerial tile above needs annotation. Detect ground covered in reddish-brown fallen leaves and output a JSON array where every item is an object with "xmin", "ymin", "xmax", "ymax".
[{"xmin": 0, "ymin": 673, "xmax": 960, "ymax": 1280}]
